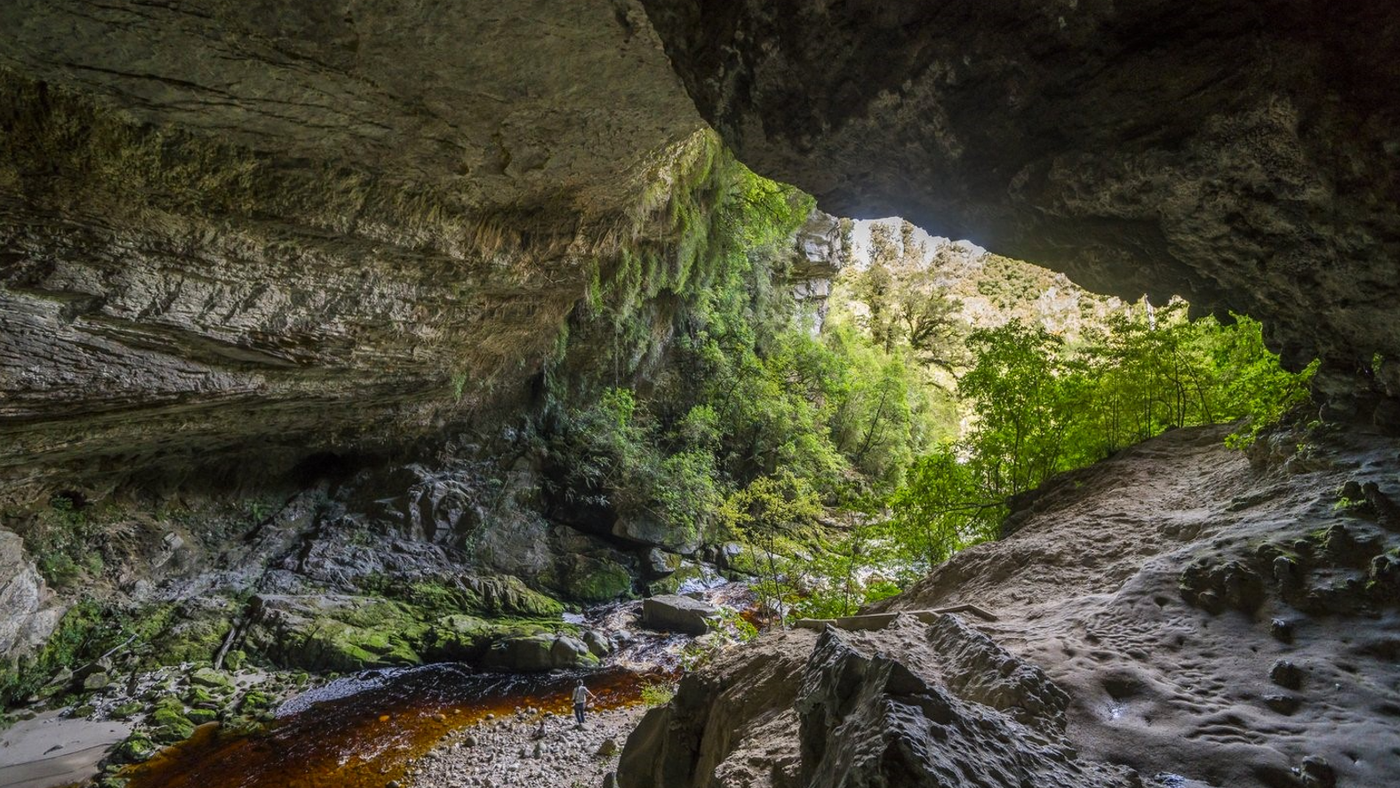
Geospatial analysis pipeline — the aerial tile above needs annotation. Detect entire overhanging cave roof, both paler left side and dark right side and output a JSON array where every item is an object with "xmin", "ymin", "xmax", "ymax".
[{"xmin": 8, "ymin": 0, "xmax": 1400, "ymax": 501}]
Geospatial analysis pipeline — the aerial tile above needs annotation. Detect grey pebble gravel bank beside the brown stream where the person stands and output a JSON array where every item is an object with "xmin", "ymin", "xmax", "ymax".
[{"xmin": 407, "ymin": 705, "xmax": 647, "ymax": 788}]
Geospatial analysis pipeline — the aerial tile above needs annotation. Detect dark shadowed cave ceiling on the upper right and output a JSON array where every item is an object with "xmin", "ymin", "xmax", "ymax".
[{"xmin": 645, "ymin": 0, "xmax": 1400, "ymax": 425}]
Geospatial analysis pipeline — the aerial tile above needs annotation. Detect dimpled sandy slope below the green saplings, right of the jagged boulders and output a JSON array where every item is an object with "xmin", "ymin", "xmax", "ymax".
[{"xmin": 883, "ymin": 428, "xmax": 1400, "ymax": 788}]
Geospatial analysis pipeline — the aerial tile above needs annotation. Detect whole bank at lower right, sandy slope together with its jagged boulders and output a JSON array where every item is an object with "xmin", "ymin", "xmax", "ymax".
[{"xmin": 619, "ymin": 427, "xmax": 1400, "ymax": 788}]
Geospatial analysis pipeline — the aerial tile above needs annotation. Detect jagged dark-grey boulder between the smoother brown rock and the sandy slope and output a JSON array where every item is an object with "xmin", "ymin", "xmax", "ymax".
[{"xmin": 795, "ymin": 616, "xmax": 1141, "ymax": 788}]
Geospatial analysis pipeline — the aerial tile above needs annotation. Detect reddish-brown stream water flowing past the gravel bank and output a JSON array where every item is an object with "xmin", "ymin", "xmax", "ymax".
[{"xmin": 125, "ymin": 665, "xmax": 648, "ymax": 788}]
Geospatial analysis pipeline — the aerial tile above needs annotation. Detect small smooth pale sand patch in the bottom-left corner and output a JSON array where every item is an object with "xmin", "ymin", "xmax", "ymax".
[{"xmin": 0, "ymin": 711, "xmax": 132, "ymax": 788}]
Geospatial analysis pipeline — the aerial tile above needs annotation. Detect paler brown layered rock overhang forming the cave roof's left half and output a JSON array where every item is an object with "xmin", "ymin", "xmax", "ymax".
[{"xmin": 0, "ymin": 0, "xmax": 700, "ymax": 502}]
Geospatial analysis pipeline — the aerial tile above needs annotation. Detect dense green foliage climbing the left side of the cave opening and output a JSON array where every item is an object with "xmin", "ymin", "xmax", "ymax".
[{"xmin": 533, "ymin": 132, "xmax": 934, "ymax": 540}]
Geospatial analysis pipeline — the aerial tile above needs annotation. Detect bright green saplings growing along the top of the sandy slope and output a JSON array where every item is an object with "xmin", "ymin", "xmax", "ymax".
[{"xmin": 888, "ymin": 301, "xmax": 1312, "ymax": 567}]
